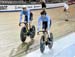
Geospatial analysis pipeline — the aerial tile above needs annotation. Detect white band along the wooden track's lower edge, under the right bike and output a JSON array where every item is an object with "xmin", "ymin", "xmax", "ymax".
[{"xmin": 23, "ymin": 33, "xmax": 75, "ymax": 57}]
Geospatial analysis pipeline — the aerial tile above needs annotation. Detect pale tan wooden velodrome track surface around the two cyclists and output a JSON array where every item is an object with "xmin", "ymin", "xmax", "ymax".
[{"xmin": 0, "ymin": 5, "xmax": 75, "ymax": 57}]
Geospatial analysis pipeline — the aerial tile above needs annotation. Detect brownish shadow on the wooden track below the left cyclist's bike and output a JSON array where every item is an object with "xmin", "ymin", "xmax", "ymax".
[{"xmin": 9, "ymin": 40, "xmax": 34, "ymax": 57}]
